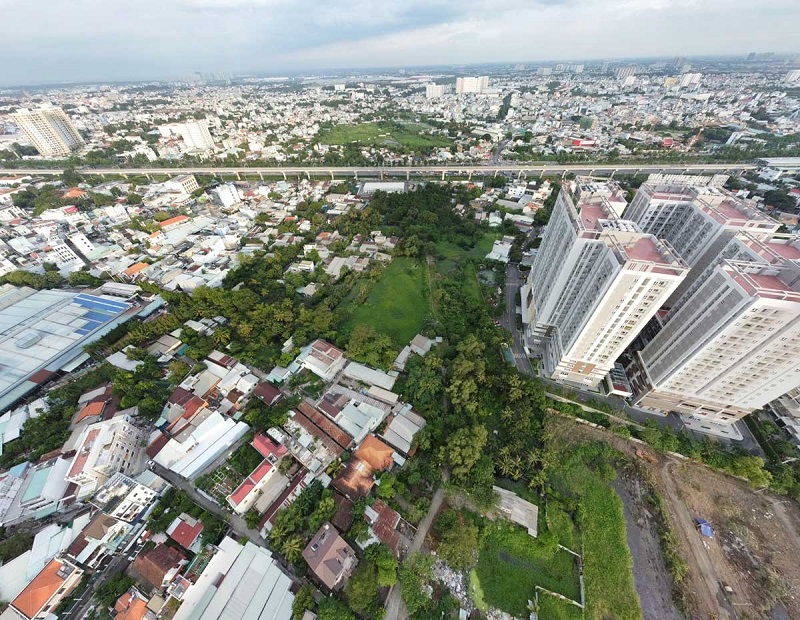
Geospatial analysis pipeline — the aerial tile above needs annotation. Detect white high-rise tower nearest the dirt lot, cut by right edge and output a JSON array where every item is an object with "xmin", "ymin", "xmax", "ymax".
[{"xmin": 628, "ymin": 261, "xmax": 800, "ymax": 430}]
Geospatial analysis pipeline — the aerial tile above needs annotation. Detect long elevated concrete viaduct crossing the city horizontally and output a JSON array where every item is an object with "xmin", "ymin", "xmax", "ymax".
[{"xmin": 0, "ymin": 162, "xmax": 758, "ymax": 178}]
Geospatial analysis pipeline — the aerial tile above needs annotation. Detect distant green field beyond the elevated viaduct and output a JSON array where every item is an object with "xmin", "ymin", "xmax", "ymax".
[{"xmin": 319, "ymin": 122, "xmax": 452, "ymax": 150}]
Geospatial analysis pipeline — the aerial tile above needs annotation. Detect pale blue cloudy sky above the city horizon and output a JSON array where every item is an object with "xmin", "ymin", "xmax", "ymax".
[{"xmin": 0, "ymin": 0, "xmax": 800, "ymax": 85}]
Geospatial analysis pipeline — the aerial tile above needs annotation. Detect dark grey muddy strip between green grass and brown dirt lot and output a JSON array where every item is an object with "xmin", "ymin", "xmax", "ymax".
[{"xmin": 613, "ymin": 477, "xmax": 684, "ymax": 620}]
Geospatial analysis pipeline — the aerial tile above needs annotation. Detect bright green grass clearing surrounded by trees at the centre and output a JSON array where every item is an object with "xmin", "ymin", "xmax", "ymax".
[{"xmin": 342, "ymin": 257, "xmax": 430, "ymax": 350}]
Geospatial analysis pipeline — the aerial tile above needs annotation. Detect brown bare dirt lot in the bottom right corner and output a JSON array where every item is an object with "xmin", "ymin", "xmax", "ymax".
[{"xmin": 661, "ymin": 463, "xmax": 800, "ymax": 619}]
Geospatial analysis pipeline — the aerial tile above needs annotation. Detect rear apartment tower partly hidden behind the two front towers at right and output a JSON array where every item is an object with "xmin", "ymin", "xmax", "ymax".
[{"xmin": 625, "ymin": 183, "xmax": 780, "ymax": 306}]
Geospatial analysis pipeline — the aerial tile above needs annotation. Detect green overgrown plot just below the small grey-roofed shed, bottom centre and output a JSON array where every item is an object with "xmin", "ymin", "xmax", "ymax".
[{"xmin": 475, "ymin": 520, "xmax": 580, "ymax": 618}]
